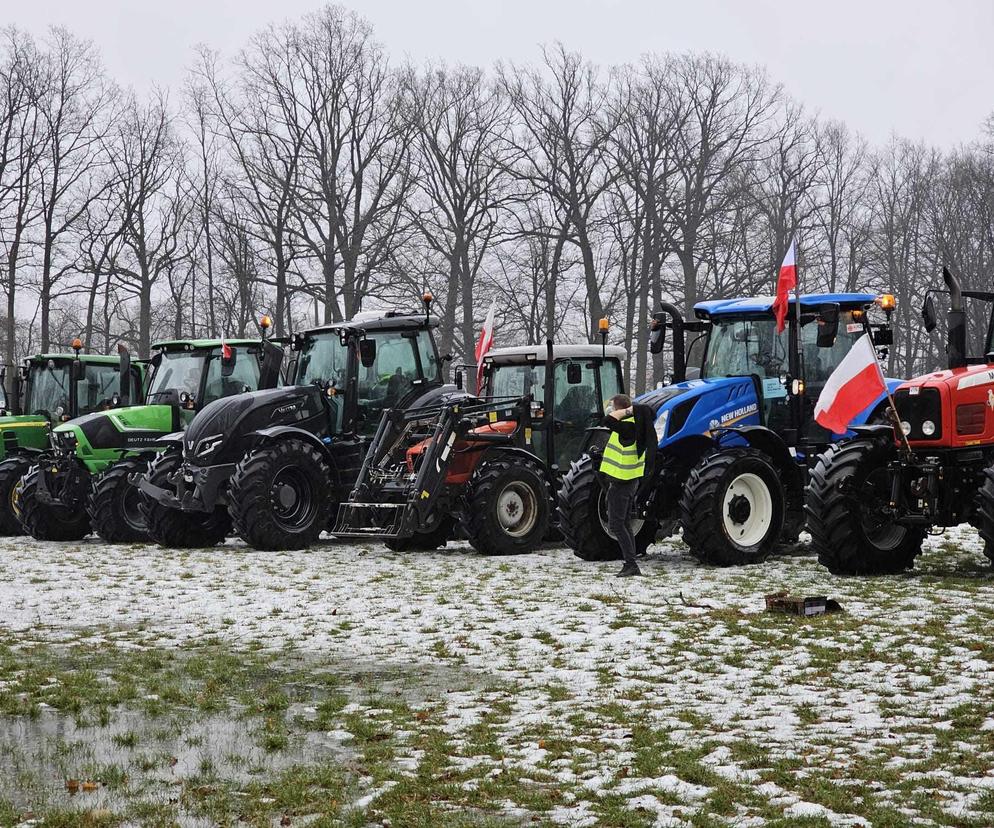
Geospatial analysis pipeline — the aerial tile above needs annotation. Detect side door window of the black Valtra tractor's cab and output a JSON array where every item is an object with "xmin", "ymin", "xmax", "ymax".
[{"xmin": 358, "ymin": 331, "xmax": 438, "ymax": 433}]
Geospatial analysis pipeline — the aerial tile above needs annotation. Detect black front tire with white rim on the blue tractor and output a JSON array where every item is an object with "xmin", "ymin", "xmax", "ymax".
[{"xmin": 680, "ymin": 448, "xmax": 784, "ymax": 566}]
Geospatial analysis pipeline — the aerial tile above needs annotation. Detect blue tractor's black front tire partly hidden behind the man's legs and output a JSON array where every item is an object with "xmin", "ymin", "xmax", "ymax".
[{"xmin": 556, "ymin": 454, "xmax": 658, "ymax": 561}]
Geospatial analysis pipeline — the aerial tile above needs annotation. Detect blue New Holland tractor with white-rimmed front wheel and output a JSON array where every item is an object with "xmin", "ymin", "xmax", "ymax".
[{"xmin": 558, "ymin": 293, "xmax": 900, "ymax": 566}]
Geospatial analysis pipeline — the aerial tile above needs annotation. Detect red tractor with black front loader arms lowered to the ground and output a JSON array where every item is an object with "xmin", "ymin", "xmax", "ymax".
[{"xmin": 332, "ymin": 340, "xmax": 625, "ymax": 555}]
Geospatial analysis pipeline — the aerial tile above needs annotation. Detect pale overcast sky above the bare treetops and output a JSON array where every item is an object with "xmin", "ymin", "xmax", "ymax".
[{"xmin": 7, "ymin": 0, "xmax": 994, "ymax": 147}]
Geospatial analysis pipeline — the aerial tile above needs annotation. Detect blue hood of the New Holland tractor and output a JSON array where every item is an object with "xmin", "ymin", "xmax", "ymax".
[{"xmin": 635, "ymin": 377, "xmax": 760, "ymax": 448}]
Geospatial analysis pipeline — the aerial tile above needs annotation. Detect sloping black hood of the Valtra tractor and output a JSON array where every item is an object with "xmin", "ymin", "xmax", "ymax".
[{"xmin": 183, "ymin": 385, "xmax": 327, "ymax": 465}]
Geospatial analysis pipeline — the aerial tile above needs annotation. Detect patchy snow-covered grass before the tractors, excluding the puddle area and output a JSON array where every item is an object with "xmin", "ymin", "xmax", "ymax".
[{"xmin": 0, "ymin": 529, "xmax": 994, "ymax": 826}]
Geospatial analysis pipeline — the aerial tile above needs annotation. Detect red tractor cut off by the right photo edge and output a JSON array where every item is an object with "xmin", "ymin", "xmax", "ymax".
[{"xmin": 805, "ymin": 269, "xmax": 994, "ymax": 575}]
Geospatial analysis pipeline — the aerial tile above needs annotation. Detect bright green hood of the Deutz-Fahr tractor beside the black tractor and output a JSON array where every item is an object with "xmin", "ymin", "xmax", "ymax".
[{"xmin": 53, "ymin": 405, "xmax": 179, "ymax": 456}]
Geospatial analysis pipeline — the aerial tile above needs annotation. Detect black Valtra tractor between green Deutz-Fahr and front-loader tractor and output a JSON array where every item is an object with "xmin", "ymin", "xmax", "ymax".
[{"xmin": 136, "ymin": 296, "xmax": 451, "ymax": 549}]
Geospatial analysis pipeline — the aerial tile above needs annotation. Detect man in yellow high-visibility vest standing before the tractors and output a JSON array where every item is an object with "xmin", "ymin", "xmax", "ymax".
[{"xmin": 600, "ymin": 394, "xmax": 655, "ymax": 578}]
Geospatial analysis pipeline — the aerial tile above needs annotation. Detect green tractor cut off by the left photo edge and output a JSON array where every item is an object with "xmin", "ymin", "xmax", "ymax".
[{"xmin": 0, "ymin": 339, "xmax": 144, "ymax": 535}]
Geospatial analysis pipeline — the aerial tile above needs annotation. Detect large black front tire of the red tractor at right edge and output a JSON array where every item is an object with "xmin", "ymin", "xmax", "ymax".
[{"xmin": 804, "ymin": 437, "xmax": 926, "ymax": 575}]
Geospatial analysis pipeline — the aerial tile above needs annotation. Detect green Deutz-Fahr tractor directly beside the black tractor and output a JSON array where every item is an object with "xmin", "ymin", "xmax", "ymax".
[{"xmin": 18, "ymin": 330, "xmax": 283, "ymax": 543}]
